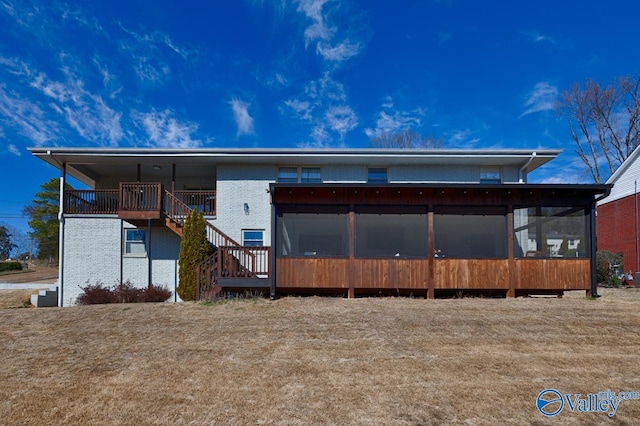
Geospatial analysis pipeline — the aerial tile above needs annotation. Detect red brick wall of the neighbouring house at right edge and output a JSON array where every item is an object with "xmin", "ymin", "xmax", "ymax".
[{"xmin": 596, "ymin": 195, "xmax": 640, "ymax": 273}]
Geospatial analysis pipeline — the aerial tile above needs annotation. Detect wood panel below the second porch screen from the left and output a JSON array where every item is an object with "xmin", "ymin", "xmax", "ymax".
[{"xmin": 353, "ymin": 259, "xmax": 429, "ymax": 289}]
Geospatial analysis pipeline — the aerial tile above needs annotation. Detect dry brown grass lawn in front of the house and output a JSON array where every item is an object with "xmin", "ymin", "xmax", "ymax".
[{"xmin": 0, "ymin": 289, "xmax": 640, "ymax": 425}]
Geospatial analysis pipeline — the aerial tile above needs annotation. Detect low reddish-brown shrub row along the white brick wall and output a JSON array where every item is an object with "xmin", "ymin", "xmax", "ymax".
[{"xmin": 76, "ymin": 281, "xmax": 171, "ymax": 305}]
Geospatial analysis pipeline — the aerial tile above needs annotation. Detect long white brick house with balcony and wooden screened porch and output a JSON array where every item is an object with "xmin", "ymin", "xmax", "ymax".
[{"xmin": 31, "ymin": 148, "xmax": 610, "ymax": 306}]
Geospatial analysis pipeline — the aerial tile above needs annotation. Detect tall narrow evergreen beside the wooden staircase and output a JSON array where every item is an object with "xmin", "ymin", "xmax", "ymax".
[{"xmin": 178, "ymin": 210, "xmax": 211, "ymax": 300}]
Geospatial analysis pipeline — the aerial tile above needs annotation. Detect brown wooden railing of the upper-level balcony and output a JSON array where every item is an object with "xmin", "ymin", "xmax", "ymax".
[{"xmin": 63, "ymin": 182, "xmax": 216, "ymax": 220}]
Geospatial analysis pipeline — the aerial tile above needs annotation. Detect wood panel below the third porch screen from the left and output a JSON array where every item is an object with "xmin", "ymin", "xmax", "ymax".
[{"xmin": 433, "ymin": 259, "xmax": 509, "ymax": 290}]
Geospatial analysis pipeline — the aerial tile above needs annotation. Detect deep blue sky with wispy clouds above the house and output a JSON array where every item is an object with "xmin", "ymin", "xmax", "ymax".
[{"xmin": 0, "ymin": 0, "xmax": 640, "ymax": 240}]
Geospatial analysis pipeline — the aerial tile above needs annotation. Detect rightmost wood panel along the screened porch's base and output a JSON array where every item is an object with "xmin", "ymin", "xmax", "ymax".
[{"xmin": 513, "ymin": 259, "xmax": 591, "ymax": 290}]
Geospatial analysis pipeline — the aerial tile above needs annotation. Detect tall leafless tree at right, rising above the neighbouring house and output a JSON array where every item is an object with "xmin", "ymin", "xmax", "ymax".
[{"xmin": 557, "ymin": 76, "xmax": 640, "ymax": 183}]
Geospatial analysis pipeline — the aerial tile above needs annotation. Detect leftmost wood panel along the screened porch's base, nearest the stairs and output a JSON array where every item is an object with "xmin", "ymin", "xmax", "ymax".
[{"xmin": 276, "ymin": 257, "xmax": 349, "ymax": 288}]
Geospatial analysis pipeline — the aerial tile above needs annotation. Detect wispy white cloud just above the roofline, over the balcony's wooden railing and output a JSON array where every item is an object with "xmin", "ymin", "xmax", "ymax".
[{"xmin": 131, "ymin": 109, "xmax": 201, "ymax": 148}]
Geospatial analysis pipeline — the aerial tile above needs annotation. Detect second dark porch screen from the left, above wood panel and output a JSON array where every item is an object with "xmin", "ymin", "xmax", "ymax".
[{"xmin": 355, "ymin": 207, "xmax": 427, "ymax": 258}]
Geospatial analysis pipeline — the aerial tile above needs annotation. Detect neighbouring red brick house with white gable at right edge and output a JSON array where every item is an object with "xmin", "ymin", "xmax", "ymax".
[{"xmin": 597, "ymin": 146, "xmax": 640, "ymax": 282}]
